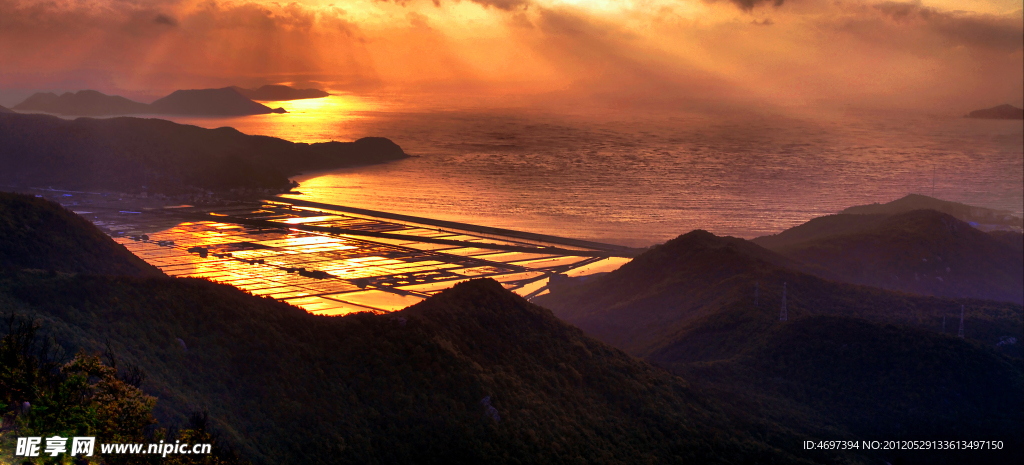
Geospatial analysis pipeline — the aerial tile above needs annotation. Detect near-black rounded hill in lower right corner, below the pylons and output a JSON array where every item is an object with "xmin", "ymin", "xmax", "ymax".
[{"xmin": 649, "ymin": 309, "xmax": 1024, "ymax": 464}]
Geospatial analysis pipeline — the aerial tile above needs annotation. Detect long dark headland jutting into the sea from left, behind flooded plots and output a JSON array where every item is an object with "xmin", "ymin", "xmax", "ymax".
[{"xmin": 0, "ymin": 115, "xmax": 407, "ymax": 194}]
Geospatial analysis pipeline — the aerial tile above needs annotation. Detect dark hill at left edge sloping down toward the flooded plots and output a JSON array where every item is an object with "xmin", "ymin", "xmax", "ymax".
[{"xmin": 0, "ymin": 193, "xmax": 164, "ymax": 277}]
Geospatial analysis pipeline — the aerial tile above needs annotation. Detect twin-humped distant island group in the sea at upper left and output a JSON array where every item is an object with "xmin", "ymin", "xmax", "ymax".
[{"xmin": 14, "ymin": 87, "xmax": 285, "ymax": 116}]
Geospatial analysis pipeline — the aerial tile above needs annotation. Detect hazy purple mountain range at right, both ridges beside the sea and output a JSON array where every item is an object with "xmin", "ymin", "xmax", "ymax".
[{"xmin": 752, "ymin": 196, "xmax": 1024, "ymax": 304}]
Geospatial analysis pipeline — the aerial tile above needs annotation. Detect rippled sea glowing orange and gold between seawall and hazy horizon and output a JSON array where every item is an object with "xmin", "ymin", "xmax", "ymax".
[{"xmin": 163, "ymin": 96, "xmax": 1024, "ymax": 246}]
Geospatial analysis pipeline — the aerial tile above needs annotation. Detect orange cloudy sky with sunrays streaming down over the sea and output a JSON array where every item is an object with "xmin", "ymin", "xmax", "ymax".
[{"xmin": 0, "ymin": 0, "xmax": 1024, "ymax": 112}]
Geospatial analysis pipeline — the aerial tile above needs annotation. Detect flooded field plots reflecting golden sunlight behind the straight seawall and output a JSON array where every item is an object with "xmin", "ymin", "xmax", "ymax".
[{"xmin": 48, "ymin": 189, "xmax": 636, "ymax": 314}]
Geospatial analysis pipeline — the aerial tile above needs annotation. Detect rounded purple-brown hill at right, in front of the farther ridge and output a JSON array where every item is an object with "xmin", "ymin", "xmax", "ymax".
[{"xmin": 755, "ymin": 210, "xmax": 1024, "ymax": 303}]
